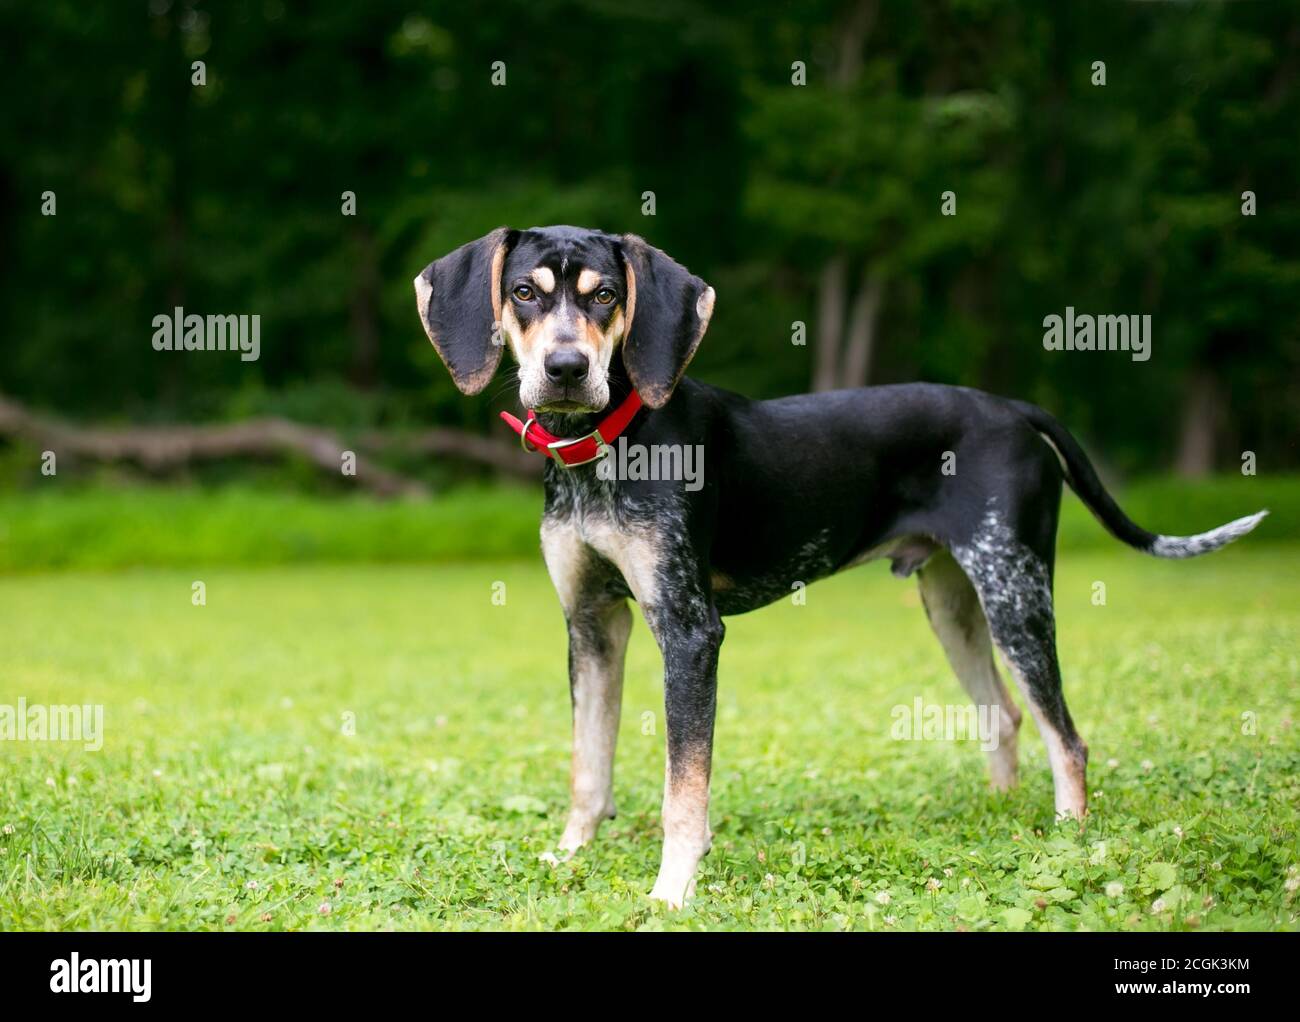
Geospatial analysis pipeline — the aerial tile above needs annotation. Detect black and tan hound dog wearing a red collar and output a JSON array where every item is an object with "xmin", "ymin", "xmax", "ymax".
[{"xmin": 415, "ymin": 226, "xmax": 1268, "ymax": 908}]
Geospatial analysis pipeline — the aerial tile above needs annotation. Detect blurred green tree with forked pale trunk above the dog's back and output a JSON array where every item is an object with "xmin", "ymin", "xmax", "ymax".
[{"xmin": 748, "ymin": 0, "xmax": 1008, "ymax": 390}]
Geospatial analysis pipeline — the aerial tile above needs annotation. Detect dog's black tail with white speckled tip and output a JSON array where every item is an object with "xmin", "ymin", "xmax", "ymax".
[{"xmin": 1011, "ymin": 400, "xmax": 1269, "ymax": 558}]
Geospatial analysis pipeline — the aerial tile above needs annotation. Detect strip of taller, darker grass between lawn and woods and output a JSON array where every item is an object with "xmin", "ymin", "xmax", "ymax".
[{"xmin": 0, "ymin": 476, "xmax": 1300, "ymax": 572}]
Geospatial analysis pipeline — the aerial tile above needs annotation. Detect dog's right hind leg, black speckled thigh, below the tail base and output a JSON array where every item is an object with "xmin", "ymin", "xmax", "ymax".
[{"xmin": 952, "ymin": 511, "xmax": 1088, "ymax": 818}]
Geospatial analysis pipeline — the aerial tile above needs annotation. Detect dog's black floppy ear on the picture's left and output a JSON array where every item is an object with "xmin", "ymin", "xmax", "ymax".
[{"xmin": 415, "ymin": 228, "xmax": 516, "ymax": 394}]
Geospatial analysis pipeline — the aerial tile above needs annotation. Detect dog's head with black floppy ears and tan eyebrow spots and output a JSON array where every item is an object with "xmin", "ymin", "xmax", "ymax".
[{"xmin": 415, "ymin": 228, "xmax": 714, "ymax": 412}]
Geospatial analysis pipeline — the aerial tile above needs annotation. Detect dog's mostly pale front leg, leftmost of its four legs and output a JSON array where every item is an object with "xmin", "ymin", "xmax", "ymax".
[{"xmin": 559, "ymin": 599, "xmax": 632, "ymax": 852}]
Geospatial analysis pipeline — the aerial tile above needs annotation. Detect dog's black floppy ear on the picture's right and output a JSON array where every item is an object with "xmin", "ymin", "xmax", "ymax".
[{"xmin": 623, "ymin": 234, "xmax": 714, "ymax": 408}]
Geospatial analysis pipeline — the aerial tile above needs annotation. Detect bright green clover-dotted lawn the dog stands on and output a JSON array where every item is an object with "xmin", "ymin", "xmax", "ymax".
[{"xmin": 0, "ymin": 546, "xmax": 1300, "ymax": 930}]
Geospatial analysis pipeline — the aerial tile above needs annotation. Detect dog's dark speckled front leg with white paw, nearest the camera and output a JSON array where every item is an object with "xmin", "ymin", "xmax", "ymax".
[{"xmin": 647, "ymin": 597, "xmax": 725, "ymax": 908}]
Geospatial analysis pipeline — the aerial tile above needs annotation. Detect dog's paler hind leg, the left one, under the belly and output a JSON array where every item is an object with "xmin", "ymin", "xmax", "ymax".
[{"xmin": 918, "ymin": 550, "xmax": 1021, "ymax": 791}]
